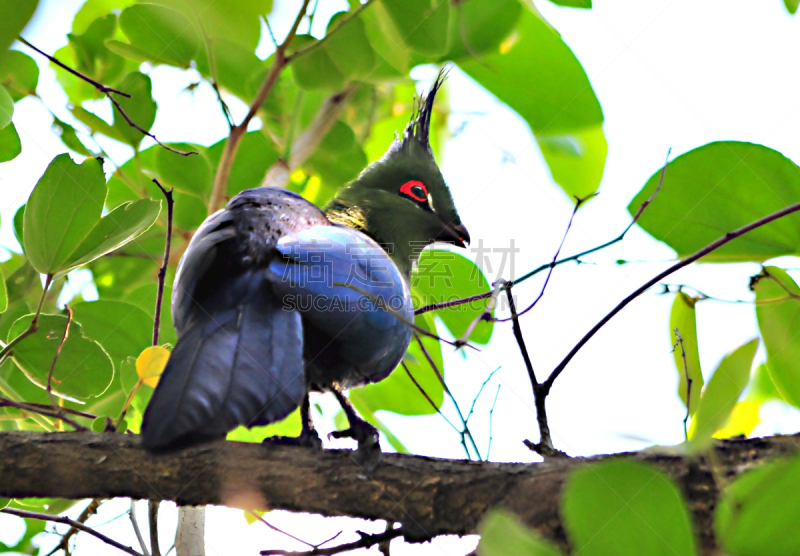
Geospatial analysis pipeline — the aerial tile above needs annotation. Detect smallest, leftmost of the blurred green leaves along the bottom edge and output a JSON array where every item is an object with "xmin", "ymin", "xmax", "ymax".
[{"xmin": 478, "ymin": 510, "xmax": 563, "ymax": 556}]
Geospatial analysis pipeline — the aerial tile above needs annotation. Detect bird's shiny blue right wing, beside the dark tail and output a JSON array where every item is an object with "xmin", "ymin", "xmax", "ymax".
[{"xmin": 268, "ymin": 226, "xmax": 414, "ymax": 388}]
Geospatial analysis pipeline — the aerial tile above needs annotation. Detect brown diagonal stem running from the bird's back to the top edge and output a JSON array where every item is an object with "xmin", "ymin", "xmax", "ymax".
[{"xmin": 208, "ymin": 0, "xmax": 310, "ymax": 213}]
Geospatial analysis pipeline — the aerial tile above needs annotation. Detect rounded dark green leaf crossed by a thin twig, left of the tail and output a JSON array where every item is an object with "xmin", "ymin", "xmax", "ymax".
[{"xmin": 8, "ymin": 315, "xmax": 114, "ymax": 399}]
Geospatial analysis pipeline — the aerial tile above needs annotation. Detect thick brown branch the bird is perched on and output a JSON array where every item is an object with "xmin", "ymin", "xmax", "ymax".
[{"xmin": 0, "ymin": 431, "xmax": 800, "ymax": 548}]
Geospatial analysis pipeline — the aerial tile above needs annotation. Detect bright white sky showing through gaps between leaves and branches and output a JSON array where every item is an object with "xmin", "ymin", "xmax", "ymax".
[{"xmin": 0, "ymin": 0, "xmax": 800, "ymax": 556}]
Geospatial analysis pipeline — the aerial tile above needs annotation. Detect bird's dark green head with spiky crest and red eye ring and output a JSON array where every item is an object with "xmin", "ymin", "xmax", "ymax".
[{"xmin": 326, "ymin": 72, "xmax": 469, "ymax": 276}]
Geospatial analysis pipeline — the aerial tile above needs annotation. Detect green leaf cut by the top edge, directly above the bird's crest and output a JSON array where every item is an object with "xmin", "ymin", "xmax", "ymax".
[{"xmin": 442, "ymin": 0, "xmax": 522, "ymax": 61}]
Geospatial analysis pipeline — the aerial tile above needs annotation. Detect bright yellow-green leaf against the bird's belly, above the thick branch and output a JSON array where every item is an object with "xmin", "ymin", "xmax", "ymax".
[{"xmin": 349, "ymin": 315, "xmax": 444, "ymax": 415}]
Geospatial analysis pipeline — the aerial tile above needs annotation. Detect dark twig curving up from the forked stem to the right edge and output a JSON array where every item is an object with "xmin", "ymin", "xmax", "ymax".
[{"xmin": 543, "ymin": 198, "xmax": 800, "ymax": 392}]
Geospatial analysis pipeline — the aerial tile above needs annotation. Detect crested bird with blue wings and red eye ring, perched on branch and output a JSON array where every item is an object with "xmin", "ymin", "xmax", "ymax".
[{"xmin": 141, "ymin": 72, "xmax": 470, "ymax": 457}]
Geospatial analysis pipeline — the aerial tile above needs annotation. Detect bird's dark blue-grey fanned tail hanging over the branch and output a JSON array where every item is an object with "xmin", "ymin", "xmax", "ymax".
[{"xmin": 142, "ymin": 276, "xmax": 306, "ymax": 451}]
